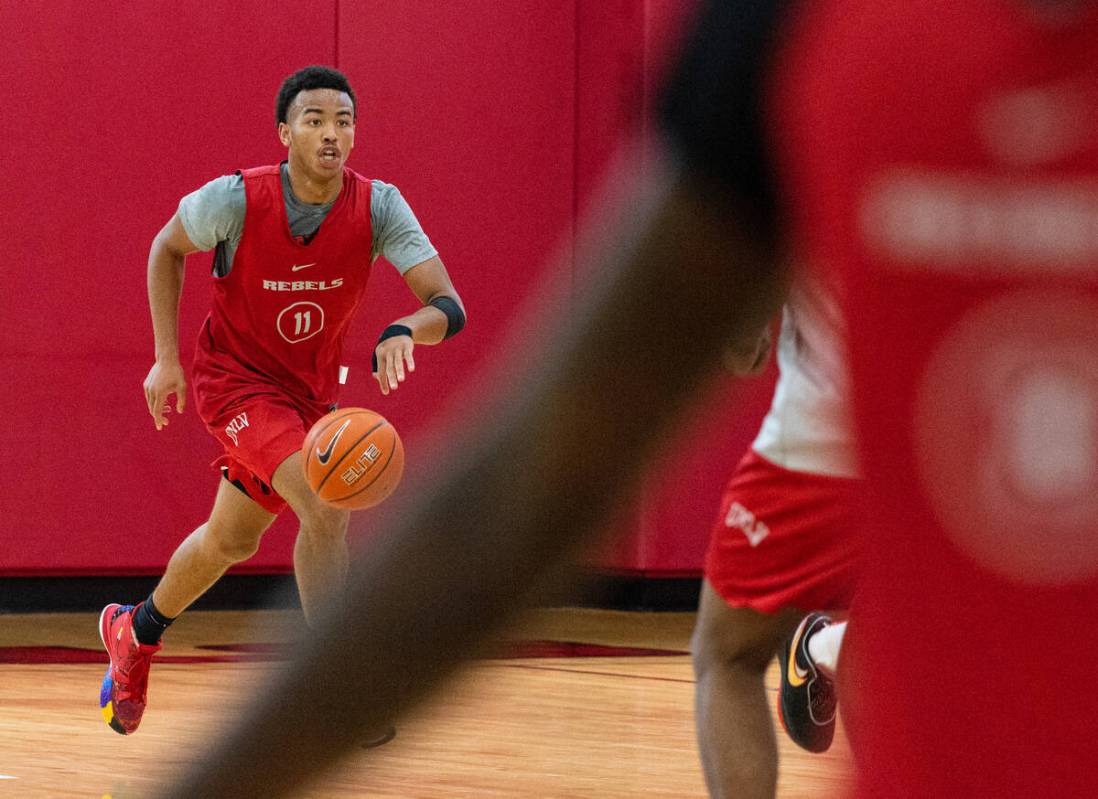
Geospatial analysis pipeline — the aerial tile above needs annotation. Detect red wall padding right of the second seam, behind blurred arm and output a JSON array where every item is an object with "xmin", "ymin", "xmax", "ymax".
[{"xmin": 576, "ymin": 0, "xmax": 774, "ymax": 576}]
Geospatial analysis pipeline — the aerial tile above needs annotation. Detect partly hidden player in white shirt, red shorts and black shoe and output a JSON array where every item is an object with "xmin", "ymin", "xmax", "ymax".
[{"xmin": 691, "ymin": 271, "xmax": 860, "ymax": 797}]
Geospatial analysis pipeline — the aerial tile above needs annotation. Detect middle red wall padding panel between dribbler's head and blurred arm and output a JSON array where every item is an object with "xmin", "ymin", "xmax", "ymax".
[{"xmin": 331, "ymin": 0, "xmax": 575, "ymax": 449}]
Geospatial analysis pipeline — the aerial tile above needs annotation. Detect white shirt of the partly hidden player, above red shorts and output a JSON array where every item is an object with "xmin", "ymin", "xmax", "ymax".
[{"xmin": 751, "ymin": 280, "xmax": 858, "ymax": 477}]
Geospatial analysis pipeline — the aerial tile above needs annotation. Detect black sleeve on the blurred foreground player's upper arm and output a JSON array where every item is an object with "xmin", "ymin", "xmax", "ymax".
[{"xmin": 659, "ymin": 0, "xmax": 796, "ymax": 241}]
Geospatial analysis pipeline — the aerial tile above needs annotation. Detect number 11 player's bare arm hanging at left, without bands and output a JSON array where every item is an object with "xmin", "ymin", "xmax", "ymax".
[{"xmin": 144, "ymin": 213, "xmax": 199, "ymax": 430}]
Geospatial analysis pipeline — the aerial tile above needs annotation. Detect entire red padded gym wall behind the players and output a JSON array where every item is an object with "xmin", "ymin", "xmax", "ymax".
[{"xmin": 0, "ymin": 0, "xmax": 765, "ymax": 574}]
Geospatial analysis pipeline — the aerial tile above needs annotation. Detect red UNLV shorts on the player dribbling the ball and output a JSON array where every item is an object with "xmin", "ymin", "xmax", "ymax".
[{"xmin": 195, "ymin": 385, "xmax": 332, "ymax": 516}]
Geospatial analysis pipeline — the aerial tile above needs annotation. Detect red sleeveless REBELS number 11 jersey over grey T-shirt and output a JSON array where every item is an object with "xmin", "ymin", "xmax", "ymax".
[{"xmin": 194, "ymin": 166, "xmax": 372, "ymax": 405}]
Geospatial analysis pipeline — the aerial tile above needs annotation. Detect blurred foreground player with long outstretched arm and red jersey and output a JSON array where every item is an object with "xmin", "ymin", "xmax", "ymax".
[{"xmin": 165, "ymin": 0, "xmax": 1098, "ymax": 798}]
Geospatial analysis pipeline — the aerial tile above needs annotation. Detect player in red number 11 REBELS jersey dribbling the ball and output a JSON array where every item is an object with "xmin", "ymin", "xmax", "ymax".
[{"xmin": 100, "ymin": 67, "xmax": 464, "ymax": 736}]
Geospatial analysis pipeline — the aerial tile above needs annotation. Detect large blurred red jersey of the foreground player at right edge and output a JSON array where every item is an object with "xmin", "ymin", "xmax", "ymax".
[{"xmin": 790, "ymin": 0, "xmax": 1098, "ymax": 797}]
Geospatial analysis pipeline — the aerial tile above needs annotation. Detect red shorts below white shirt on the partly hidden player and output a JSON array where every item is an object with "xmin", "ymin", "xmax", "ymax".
[{"xmin": 705, "ymin": 450, "xmax": 861, "ymax": 614}]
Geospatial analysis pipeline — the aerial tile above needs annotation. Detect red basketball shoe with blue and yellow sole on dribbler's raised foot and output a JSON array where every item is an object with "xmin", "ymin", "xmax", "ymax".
[{"xmin": 99, "ymin": 605, "xmax": 160, "ymax": 735}]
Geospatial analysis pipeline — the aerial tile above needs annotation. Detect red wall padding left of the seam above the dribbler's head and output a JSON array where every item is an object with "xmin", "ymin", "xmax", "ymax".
[{"xmin": 0, "ymin": 0, "xmax": 335, "ymax": 574}]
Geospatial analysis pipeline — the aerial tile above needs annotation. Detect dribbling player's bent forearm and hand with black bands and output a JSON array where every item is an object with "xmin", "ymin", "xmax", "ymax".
[{"xmin": 373, "ymin": 256, "xmax": 466, "ymax": 394}]
